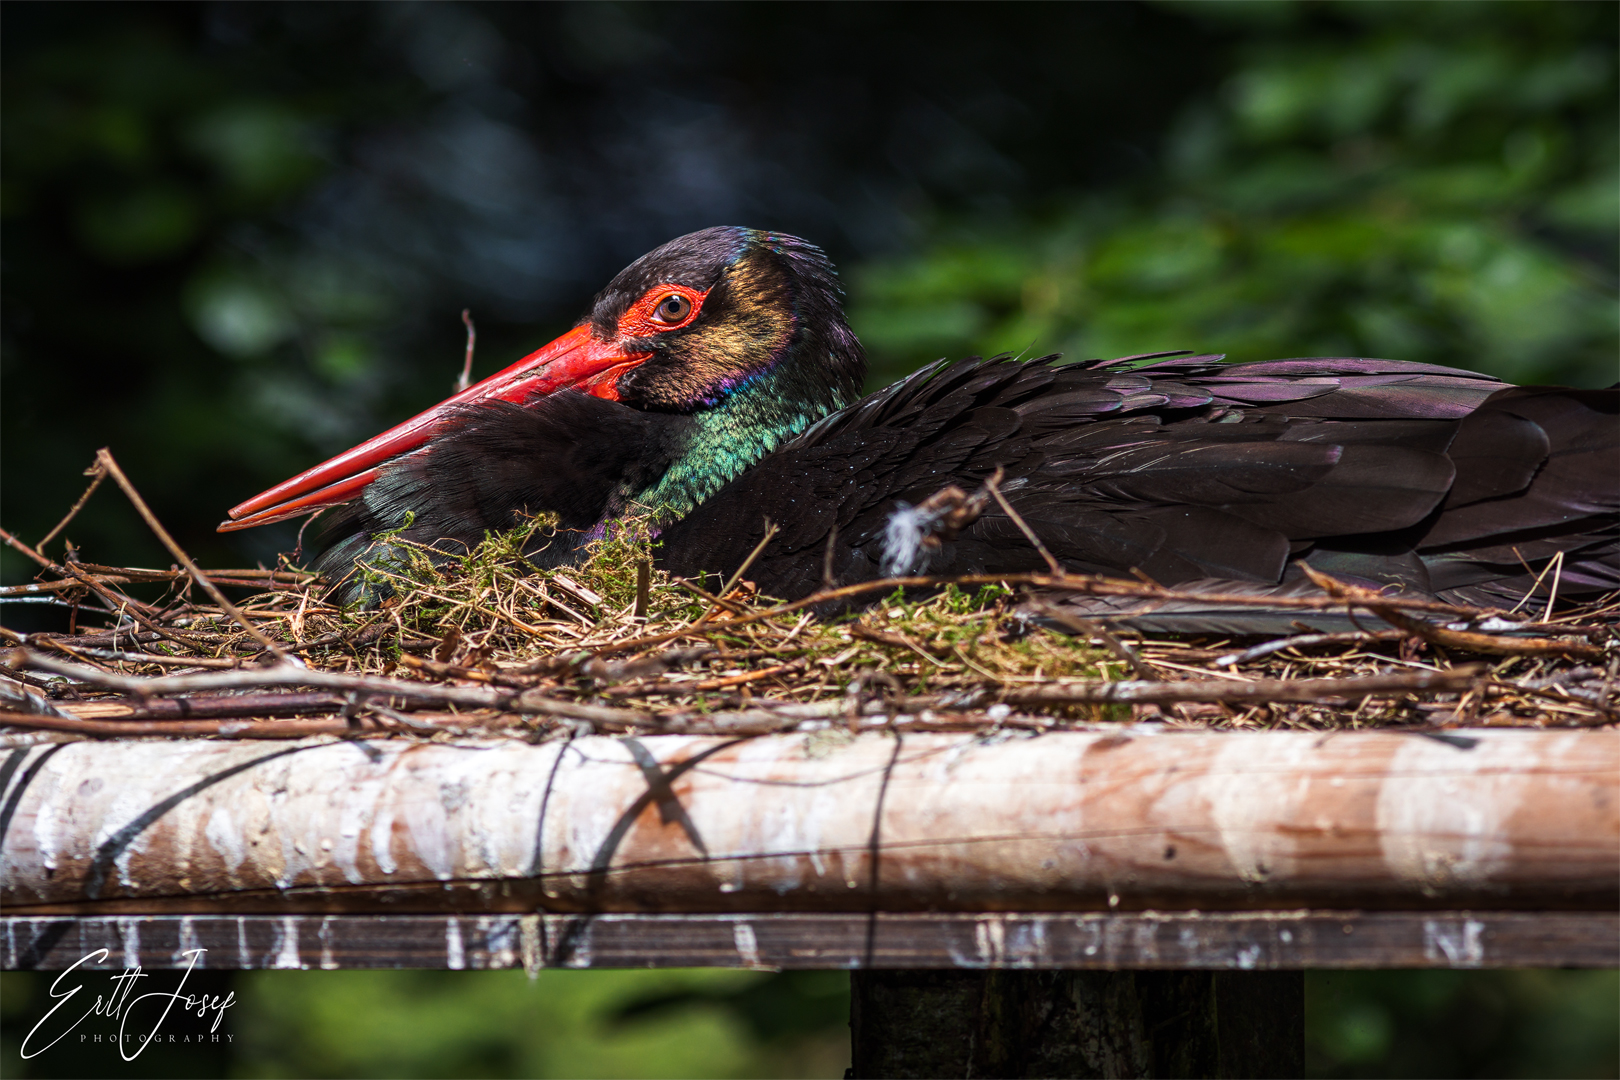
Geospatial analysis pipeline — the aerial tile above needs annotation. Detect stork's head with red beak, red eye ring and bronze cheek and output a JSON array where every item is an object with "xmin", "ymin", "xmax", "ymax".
[{"xmin": 219, "ymin": 227, "xmax": 865, "ymax": 533}]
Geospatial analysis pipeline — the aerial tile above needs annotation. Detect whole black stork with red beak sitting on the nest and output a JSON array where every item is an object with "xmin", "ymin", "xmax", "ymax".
[{"xmin": 220, "ymin": 228, "xmax": 1620, "ymax": 625}]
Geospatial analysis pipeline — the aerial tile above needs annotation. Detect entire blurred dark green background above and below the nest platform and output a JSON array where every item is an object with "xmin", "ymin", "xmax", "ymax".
[{"xmin": 0, "ymin": 2, "xmax": 1620, "ymax": 1077}]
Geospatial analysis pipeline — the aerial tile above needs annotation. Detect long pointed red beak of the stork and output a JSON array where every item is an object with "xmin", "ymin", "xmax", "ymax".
[{"xmin": 219, "ymin": 324, "xmax": 651, "ymax": 533}]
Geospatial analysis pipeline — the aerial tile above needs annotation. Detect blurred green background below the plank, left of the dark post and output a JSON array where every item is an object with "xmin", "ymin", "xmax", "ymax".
[{"xmin": 0, "ymin": 970, "xmax": 849, "ymax": 1080}]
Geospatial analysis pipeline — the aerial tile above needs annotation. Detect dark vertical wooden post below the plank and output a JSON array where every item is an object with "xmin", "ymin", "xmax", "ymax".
[{"xmin": 849, "ymin": 970, "xmax": 1304, "ymax": 1078}]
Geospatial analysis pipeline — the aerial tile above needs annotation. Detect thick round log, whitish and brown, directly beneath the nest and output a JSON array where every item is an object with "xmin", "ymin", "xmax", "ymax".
[{"xmin": 0, "ymin": 729, "xmax": 1620, "ymax": 915}]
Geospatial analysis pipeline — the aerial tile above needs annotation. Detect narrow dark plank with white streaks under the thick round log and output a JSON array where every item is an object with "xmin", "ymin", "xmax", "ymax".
[{"xmin": 0, "ymin": 912, "xmax": 1620, "ymax": 972}]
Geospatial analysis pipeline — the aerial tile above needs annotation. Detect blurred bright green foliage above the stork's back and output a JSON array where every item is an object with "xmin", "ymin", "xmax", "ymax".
[{"xmin": 852, "ymin": 3, "xmax": 1620, "ymax": 385}]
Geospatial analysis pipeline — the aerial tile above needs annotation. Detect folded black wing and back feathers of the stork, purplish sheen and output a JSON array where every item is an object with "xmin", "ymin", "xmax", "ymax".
[{"xmin": 663, "ymin": 356, "xmax": 1620, "ymax": 628}]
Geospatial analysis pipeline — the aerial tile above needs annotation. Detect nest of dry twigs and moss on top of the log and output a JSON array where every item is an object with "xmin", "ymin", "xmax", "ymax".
[{"xmin": 0, "ymin": 450, "xmax": 1620, "ymax": 745}]
